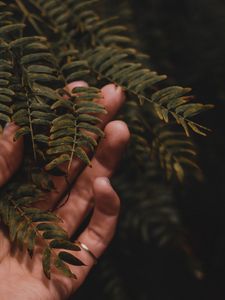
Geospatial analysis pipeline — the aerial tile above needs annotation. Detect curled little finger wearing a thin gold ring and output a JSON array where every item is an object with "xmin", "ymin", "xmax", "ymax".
[{"xmin": 64, "ymin": 177, "xmax": 120, "ymax": 287}]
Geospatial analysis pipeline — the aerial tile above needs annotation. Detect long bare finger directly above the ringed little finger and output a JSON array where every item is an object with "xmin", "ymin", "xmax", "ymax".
[{"xmin": 57, "ymin": 121, "xmax": 130, "ymax": 235}]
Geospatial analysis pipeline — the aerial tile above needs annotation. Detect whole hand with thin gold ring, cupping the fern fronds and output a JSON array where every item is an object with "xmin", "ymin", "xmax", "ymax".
[{"xmin": 0, "ymin": 82, "xmax": 129, "ymax": 300}]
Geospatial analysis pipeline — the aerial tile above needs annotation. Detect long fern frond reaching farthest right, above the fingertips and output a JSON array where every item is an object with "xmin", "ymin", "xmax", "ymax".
[{"xmin": 83, "ymin": 46, "xmax": 213, "ymax": 136}]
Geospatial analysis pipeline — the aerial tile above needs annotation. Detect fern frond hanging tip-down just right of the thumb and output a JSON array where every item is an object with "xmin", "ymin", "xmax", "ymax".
[{"xmin": 13, "ymin": 38, "xmax": 59, "ymax": 159}]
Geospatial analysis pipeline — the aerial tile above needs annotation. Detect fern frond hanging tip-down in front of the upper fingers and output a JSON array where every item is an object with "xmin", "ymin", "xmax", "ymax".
[{"xmin": 46, "ymin": 87, "xmax": 106, "ymax": 171}]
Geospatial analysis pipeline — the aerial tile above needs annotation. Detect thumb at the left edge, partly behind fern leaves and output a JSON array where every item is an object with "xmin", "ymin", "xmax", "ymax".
[{"xmin": 0, "ymin": 123, "xmax": 23, "ymax": 187}]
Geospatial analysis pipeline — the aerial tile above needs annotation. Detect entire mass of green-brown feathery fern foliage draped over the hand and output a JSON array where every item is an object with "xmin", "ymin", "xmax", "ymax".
[{"xmin": 0, "ymin": 0, "xmax": 211, "ymax": 278}]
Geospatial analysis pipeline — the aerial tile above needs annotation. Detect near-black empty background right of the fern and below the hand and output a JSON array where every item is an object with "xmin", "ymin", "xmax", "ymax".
[{"xmin": 74, "ymin": 0, "xmax": 225, "ymax": 300}]
